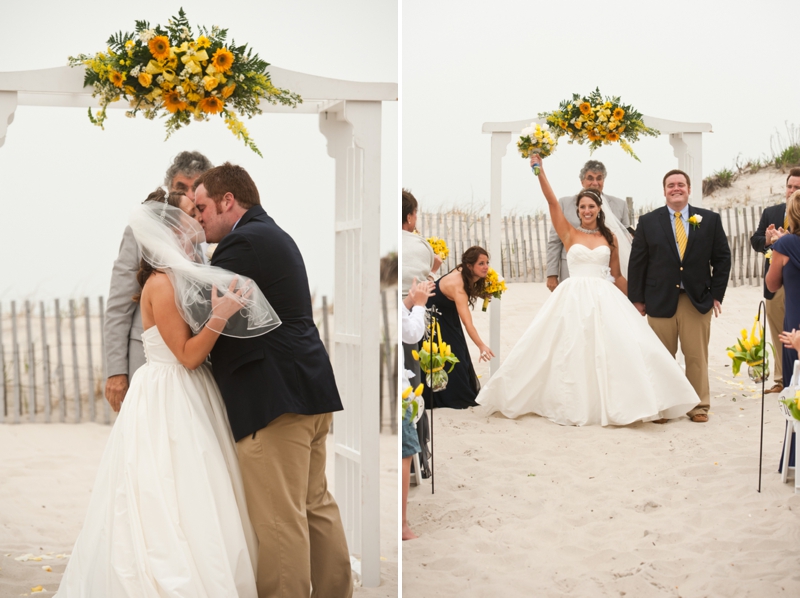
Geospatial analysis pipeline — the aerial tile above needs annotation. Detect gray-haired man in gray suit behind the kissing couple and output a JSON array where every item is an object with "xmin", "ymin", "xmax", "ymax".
[{"xmin": 103, "ymin": 152, "xmax": 214, "ymax": 411}]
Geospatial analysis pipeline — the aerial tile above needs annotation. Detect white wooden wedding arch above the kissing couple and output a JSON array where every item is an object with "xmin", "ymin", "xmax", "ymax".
[{"xmin": 0, "ymin": 66, "xmax": 398, "ymax": 587}]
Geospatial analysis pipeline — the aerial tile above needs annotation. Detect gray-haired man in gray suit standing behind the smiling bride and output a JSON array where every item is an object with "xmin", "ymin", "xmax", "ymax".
[{"xmin": 547, "ymin": 160, "xmax": 631, "ymax": 292}]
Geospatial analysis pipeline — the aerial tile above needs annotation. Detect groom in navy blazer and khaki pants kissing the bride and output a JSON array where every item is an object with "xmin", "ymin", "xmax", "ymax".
[{"xmin": 195, "ymin": 162, "xmax": 353, "ymax": 597}]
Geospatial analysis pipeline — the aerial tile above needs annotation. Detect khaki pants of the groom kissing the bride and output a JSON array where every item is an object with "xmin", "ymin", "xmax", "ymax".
[{"xmin": 236, "ymin": 413, "xmax": 353, "ymax": 598}]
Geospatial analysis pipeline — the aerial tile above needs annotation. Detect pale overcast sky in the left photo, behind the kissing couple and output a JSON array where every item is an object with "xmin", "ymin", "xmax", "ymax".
[{"xmin": 0, "ymin": 0, "xmax": 399, "ymax": 303}]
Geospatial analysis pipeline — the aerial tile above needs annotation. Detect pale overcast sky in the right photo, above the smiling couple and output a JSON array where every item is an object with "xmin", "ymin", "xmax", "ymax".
[{"xmin": 401, "ymin": 0, "xmax": 800, "ymax": 220}]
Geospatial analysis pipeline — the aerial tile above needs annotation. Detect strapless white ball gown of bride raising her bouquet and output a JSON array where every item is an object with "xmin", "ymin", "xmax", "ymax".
[{"xmin": 476, "ymin": 245, "xmax": 700, "ymax": 426}]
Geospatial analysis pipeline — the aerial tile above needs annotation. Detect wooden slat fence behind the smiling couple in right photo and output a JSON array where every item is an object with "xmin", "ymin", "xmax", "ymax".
[{"xmin": 417, "ymin": 206, "xmax": 776, "ymax": 287}]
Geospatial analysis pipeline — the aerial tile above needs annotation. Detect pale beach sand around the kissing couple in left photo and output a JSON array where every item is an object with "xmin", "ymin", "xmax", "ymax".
[{"xmin": 0, "ymin": 423, "xmax": 398, "ymax": 598}]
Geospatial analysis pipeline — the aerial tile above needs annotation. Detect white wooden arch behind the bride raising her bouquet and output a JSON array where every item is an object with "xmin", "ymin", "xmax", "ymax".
[{"xmin": 482, "ymin": 116, "xmax": 712, "ymax": 376}]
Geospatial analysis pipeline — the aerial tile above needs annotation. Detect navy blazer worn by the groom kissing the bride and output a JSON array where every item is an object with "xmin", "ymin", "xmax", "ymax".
[{"xmin": 211, "ymin": 206, "xmax": 342, "ymax": 441}]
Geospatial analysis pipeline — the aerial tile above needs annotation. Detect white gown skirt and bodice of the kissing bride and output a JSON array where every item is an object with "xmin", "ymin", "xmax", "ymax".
[{"xmin": 56, "ymin": 326, "xmax": 257, "ymax": 598}]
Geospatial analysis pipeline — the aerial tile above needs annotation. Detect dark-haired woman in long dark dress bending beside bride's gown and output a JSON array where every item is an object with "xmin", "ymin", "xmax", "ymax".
[{"xmin": 423, "ymin": 246, "xmax": 494, "ymax": 409}]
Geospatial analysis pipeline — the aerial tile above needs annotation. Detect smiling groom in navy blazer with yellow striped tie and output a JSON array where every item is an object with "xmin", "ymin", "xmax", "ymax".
[{"xmin": 628, "ymin": 170, "xmax": 731, "ymax": 423}]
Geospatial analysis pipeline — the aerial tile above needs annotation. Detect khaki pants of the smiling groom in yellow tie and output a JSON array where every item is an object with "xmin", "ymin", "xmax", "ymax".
[{"xmin": 647, "ymin": 293, "xmax": 713, "ymax": 417}]
